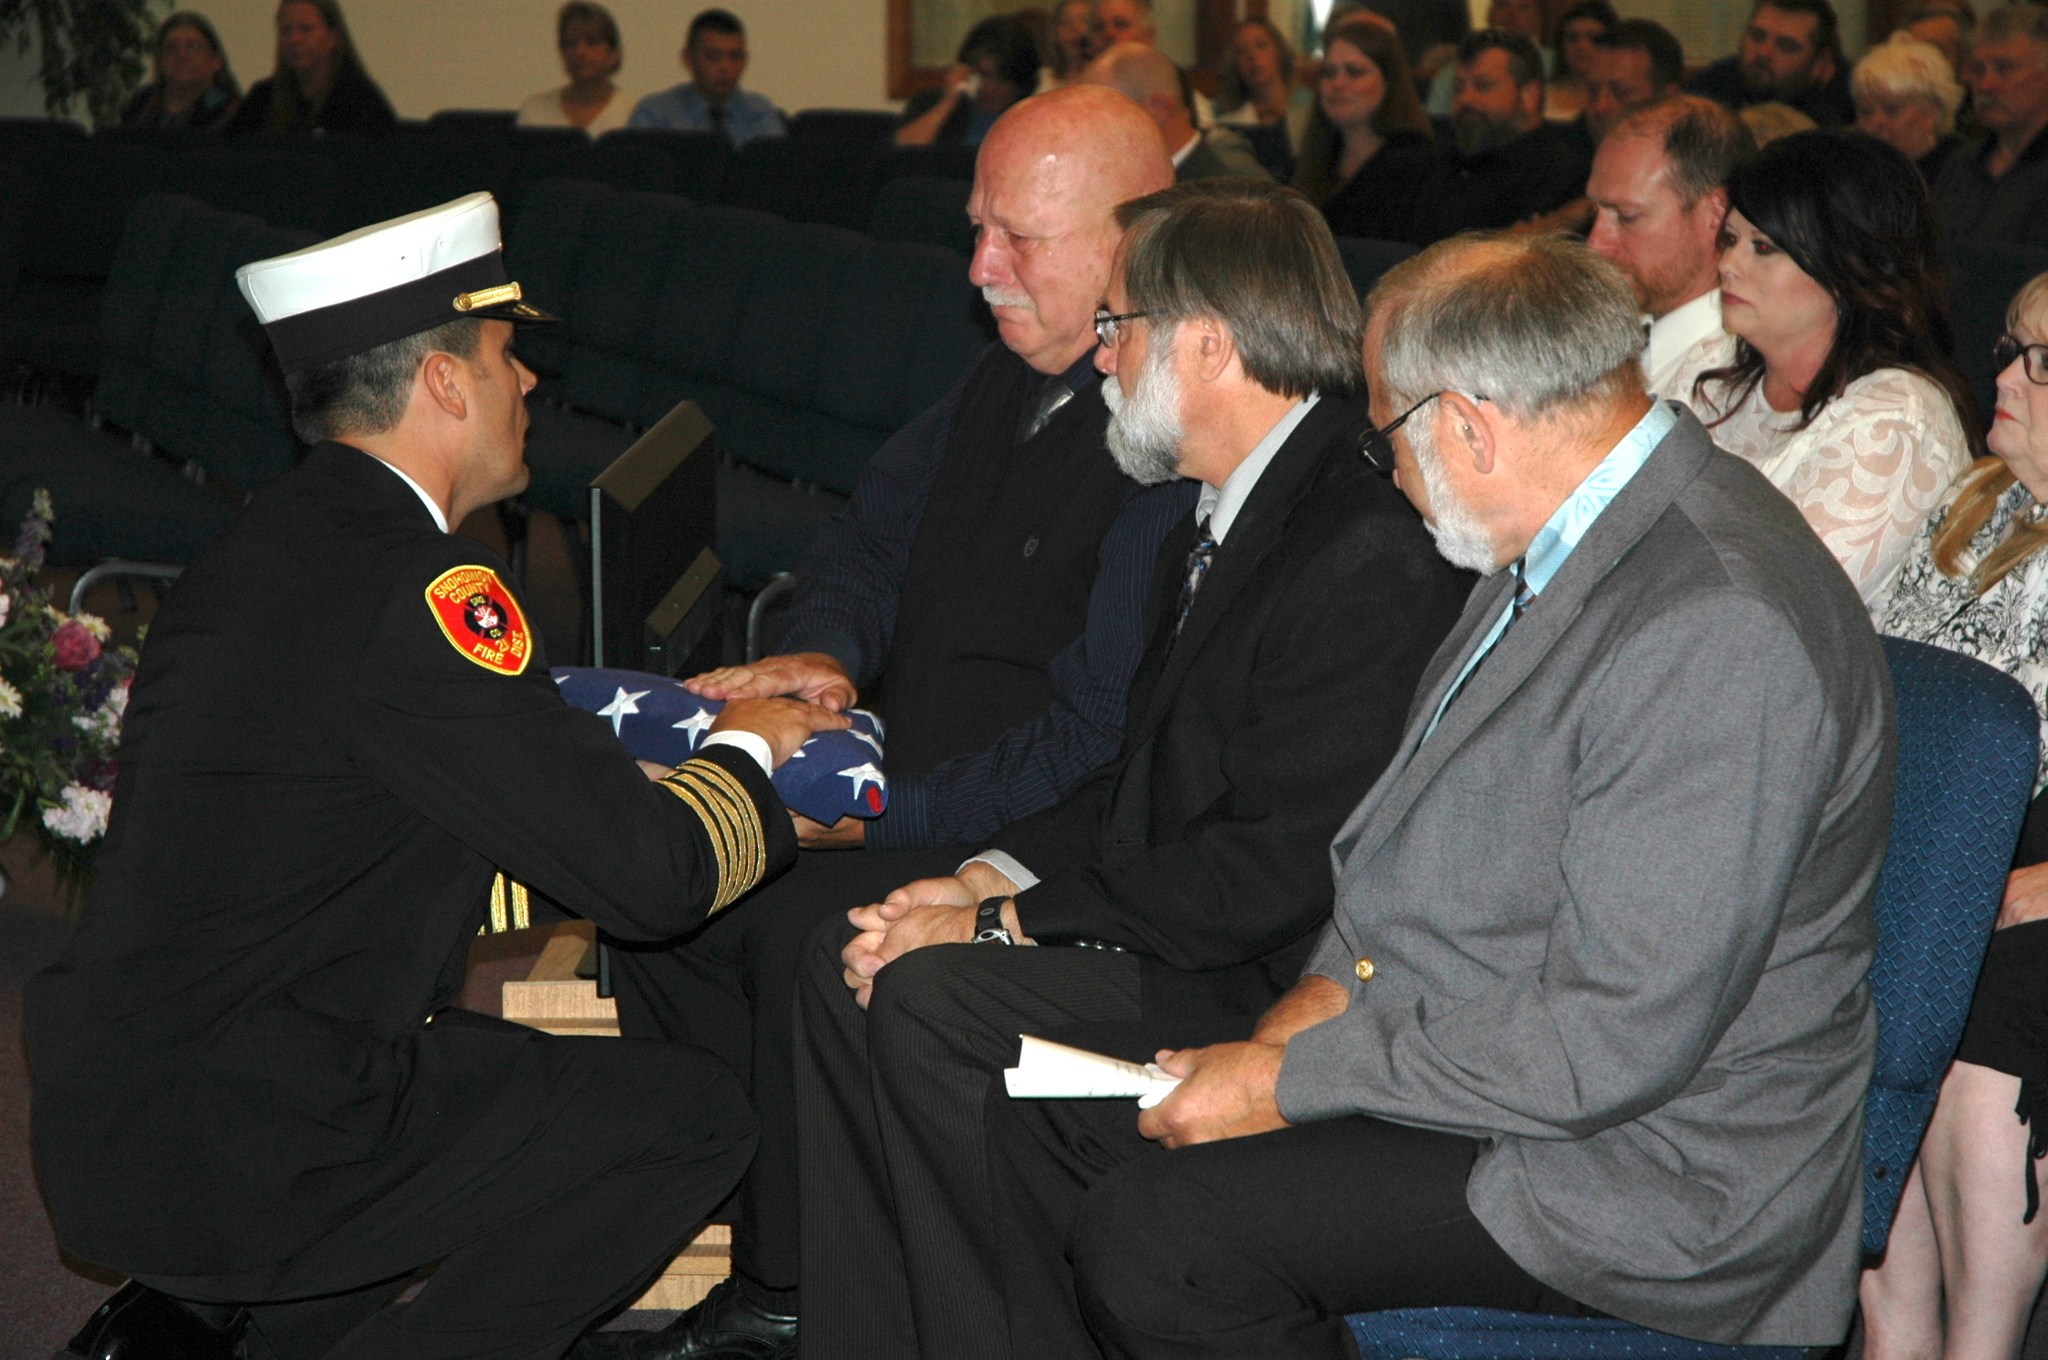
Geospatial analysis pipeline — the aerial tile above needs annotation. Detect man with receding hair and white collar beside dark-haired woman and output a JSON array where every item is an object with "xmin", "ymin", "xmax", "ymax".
[{"xmin": 1585, "ymin": 94, "xmax": 1755, "ymax": 401}]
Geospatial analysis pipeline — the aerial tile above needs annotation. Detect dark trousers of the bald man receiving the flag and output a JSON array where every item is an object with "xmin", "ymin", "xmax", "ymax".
[{"xmin": 612, "ymin": 850, "xmax": 969, "ymax": 1313}]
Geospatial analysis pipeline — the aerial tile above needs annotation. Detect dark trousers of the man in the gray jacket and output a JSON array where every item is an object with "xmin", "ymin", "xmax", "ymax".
[{"xmin": 987, "ymin": 1018, "xmax": 1583, "ymax": 1360}]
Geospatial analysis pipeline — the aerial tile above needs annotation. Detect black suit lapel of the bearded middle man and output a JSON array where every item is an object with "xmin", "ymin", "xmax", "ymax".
[{"xmin": 1135, "ymin": 397, "xmax": 1360, "ymax": 739}]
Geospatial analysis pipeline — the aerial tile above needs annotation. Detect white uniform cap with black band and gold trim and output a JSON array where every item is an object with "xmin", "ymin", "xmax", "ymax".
[{"xmin": 236, "ymin": 193, "xmax": 555, "ymax": 373}]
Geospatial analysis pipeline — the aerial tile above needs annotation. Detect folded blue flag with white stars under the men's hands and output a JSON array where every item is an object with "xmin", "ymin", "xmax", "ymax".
[{"xmin": 553, "ymin": 666, "xmax": 889, "ymax": 825}]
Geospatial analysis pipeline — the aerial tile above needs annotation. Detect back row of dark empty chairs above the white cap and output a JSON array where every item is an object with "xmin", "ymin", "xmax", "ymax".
[{"xmin": 0, "ymin": 119, "xmax": 971, "ymax": 383}]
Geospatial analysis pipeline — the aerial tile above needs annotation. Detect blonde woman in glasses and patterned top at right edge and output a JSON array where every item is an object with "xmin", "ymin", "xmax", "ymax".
[{"xmin": 1864, "ymin": 274, "xmax": 2048, "ymax": 1358}]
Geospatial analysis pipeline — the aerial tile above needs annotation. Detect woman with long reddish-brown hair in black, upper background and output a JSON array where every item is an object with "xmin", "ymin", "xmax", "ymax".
[{"xmin": 1294, "ymin": 14, "xmax": 1436, "ymax": 240}]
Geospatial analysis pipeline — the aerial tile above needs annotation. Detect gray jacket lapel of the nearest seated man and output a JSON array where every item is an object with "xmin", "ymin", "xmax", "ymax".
[{"xmin": 1331, "ymin": 414, "xmax": 1712, "ymax": 870}]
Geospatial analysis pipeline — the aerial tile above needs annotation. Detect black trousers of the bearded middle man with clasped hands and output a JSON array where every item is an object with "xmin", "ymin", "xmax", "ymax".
[{"xmin": 797, "ymin": 924, "xmax": 1245, "ymax": 1360}]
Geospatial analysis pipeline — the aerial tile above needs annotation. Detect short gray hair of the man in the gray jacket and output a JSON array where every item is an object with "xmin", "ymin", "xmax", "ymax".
[{"xmin": 1366, "ymin": 231, "xmax": 1642, "ymax": 420}]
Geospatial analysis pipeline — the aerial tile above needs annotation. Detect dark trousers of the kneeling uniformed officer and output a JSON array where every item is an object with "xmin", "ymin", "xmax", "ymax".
[{"xmin": 143, "ymin": 1036, "xmax": 754, "ymax": 1360}]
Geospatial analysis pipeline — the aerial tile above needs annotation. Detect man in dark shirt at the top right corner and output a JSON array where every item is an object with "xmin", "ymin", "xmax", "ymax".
[{"xmin": 1933, "ymin": 4, "xmax": 2048, "ymax": 246}]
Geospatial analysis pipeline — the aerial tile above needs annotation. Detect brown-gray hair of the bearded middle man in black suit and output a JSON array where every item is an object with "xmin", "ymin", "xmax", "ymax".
[{"xmin": 1116, "ymin": 178, "xmax": 1364, "ymax": 397}]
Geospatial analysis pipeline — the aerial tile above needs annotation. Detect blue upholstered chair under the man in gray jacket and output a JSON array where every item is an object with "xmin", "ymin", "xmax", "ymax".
[{"xmin": 1350, "ymin": 637, "xmax": 2040, "ymax": 1360}]
